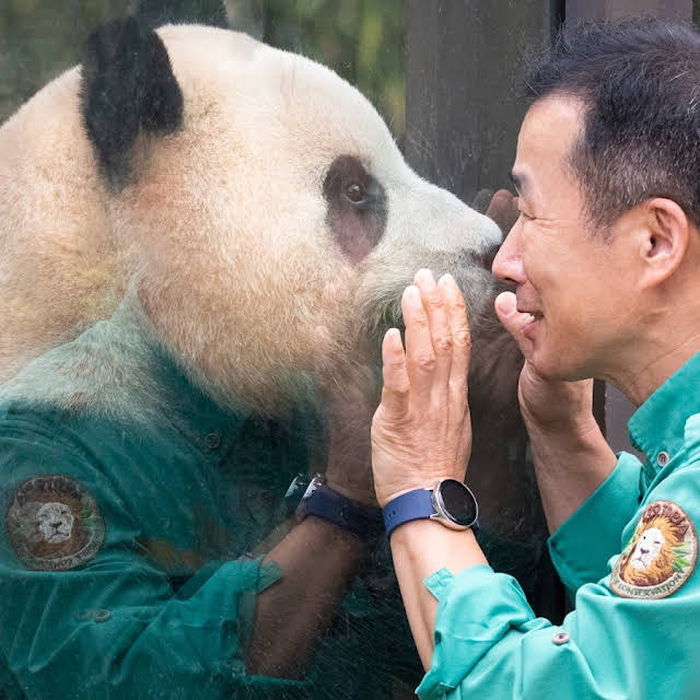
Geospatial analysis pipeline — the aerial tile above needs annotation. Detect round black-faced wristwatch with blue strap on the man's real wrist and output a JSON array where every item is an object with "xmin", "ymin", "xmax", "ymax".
[{"xmin": 382, "ymin": 479, "xmax": 479, "ymax": 537}]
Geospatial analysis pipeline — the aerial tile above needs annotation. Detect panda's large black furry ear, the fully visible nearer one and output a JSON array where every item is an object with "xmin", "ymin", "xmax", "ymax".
[{"xmin": 81, "ymin": 17, "xmax": 183, "ymax": 189}]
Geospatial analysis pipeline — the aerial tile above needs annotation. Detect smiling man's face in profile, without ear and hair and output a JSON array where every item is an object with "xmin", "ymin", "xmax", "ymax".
[{"xmin": 493, "ymin": 97, "xmax": 634, "ymax": 380}]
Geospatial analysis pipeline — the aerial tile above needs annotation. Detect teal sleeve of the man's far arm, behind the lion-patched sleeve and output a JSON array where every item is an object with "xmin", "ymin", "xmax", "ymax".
[{"xmin": 547, "ymin": 452, "xmax": 642, "ymax": 596}]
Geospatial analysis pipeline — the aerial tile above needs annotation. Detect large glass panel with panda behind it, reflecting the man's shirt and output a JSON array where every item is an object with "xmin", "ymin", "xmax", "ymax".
[{"xmin": 0, "ymin": 0, "xmax": 563, "ymax": 700}]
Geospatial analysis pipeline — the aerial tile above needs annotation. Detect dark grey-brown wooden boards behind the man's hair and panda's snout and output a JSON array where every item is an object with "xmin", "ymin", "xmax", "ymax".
[{"xmin": 406, "ymin": 0, "xmax": 693, "ymax": 201}]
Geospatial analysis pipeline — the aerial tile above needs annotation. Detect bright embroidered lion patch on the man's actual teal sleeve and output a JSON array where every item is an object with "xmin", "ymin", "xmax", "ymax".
[{"xmin": 610, "ymin": 501, "xmax": 698, "ymax": 598}]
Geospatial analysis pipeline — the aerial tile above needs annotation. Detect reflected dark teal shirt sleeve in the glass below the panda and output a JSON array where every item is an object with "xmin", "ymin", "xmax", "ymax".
[{"xmin": 0, "ymin": 422, "xmax": 309, "ymax": 700}]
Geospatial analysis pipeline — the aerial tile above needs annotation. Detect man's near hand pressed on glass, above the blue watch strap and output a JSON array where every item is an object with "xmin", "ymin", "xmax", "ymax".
[{"xmin": 372, "ymin": 270, "xmax": 471, "ymax": 506}]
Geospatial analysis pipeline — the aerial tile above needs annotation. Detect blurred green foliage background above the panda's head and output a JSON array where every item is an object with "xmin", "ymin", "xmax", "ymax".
[{"xmin": 0, "ymin": 0, "xmax": 406, "ymax": 139}]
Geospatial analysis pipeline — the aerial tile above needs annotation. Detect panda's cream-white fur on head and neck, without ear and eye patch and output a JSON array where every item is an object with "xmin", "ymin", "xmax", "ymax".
[{"xmin": 0, "ymin": 26, "xmax": 501, "ymax": 412}]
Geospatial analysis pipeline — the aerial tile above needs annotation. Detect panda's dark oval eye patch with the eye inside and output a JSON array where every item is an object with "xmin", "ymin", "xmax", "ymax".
[{"xmin": 323, "ymin": 155, "xmax": 387, "ymax": 262}]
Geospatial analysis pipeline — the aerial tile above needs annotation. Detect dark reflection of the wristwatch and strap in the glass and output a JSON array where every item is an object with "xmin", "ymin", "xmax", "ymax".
[{"xmin": 296, "ymin": 474, "xmax": 382, "ymax": 542}]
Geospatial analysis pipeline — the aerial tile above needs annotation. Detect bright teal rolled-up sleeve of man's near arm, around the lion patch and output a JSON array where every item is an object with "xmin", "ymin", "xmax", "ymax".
[{"xmin": 417, "ymin": 465, "xmax": 700, "ymax": 700}]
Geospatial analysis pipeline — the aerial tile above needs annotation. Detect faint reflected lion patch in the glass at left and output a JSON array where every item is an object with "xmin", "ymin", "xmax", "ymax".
[{"xmin": 6, "ymin": 474, "xmax": 105, "ymax": 571}]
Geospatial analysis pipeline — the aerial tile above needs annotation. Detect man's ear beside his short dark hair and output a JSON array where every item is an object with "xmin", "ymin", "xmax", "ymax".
[{"xmin": 640, "ymin": 197, "xmax": 693, "ymax": 287}]
